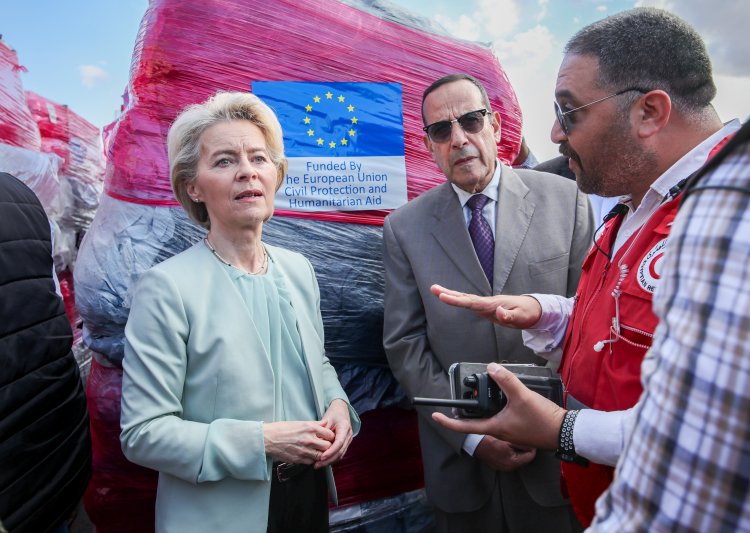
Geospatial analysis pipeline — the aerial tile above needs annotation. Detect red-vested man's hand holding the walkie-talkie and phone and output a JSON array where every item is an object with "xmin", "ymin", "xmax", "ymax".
[{"xmin": 432, "ymin": 363, "xmax": 565, "ymax": 448}]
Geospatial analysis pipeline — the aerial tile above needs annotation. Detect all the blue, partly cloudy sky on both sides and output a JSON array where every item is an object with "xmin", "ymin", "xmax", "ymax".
[{"xmin": 0, "ymin": 0, "xmax": 750, "ymax": 160}]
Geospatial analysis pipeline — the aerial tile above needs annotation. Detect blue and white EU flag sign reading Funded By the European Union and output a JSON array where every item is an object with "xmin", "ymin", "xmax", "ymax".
[{"xmin": 252, "ymin": 81, "xmax": 406, "ymax": 211}]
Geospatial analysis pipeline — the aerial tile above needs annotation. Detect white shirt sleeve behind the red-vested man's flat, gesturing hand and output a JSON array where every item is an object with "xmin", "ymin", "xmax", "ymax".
[{"xmin": 521, "ymin": 294, "xmax": 575, "ymax": 363}]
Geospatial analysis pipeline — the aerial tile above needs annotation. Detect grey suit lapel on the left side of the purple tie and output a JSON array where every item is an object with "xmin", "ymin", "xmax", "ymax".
[{"xmin": 432, "ymin": 183, "xmax": 490, "ymax": 295}]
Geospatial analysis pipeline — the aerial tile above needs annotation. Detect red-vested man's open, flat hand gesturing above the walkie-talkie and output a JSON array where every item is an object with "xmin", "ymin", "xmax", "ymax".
[{"xmin": 430, "ymin": 285, "xmax": 542, "ymax": 329}]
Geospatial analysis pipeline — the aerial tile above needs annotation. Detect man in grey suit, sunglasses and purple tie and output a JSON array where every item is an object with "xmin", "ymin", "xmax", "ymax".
[{"xmin": 383, "ymin": 74, "xmax": 593, "ymax": 532}]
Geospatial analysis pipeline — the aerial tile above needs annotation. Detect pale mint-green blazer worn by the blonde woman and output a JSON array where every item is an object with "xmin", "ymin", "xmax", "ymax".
[{"xmin": 120, "ymin": 242, "xmax": 360, "ymax": 533}]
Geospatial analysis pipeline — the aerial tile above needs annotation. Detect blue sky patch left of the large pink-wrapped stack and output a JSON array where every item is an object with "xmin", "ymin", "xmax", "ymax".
[{"xmin": 0, "ymin": 0, "xmax": 148, "ymax": 127}]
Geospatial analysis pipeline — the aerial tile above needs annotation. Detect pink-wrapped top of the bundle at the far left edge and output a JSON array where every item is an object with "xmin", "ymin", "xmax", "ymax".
[{"xmin": 0, "ymin": 39, "xmax": 41, "ymax": 152}]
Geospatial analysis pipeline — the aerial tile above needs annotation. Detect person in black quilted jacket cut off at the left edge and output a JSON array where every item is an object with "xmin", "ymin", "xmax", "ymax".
[{"xmin": 0, "ymin": 172, "xmax": 91, "ymax": 533}]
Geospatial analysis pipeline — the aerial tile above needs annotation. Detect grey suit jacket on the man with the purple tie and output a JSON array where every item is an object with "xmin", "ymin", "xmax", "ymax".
[{"xmin": 383, "ymin": 166, "xmax": 593, "ymax": 512}]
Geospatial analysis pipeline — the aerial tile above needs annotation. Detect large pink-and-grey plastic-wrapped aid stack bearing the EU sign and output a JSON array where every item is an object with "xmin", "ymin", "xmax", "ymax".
[{"xmin": 75, "ymin": 0, "xmax": 521, "ymax": 533}]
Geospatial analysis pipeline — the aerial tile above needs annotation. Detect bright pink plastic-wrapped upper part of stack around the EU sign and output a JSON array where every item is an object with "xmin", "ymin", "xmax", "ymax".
[{"xmin": 105, "ymin": 0, "xmax": 521, "ymax": 224}]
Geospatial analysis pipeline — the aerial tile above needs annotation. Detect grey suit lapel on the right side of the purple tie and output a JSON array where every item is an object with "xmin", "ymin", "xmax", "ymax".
[{"xmin": 493, "ymin": 166, "xmax": 544, "ymax": 294}]
